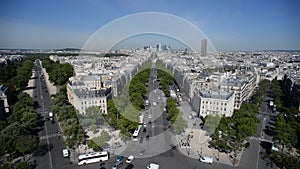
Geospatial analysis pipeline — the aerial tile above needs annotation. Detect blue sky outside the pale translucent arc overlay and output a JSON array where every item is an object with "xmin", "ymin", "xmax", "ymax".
[{"xmin": 0, "ymin": 0, "xmax": 300, "ymax": 51}]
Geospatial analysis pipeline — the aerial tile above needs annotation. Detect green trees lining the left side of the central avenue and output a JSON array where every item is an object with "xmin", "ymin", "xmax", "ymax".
[{"xmin": 80, "ymin": 61, "xmax": 151, "ymax": 148}]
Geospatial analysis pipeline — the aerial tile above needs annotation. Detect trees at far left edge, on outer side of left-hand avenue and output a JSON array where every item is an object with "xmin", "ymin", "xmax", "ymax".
[{"xmin": 0, "ymin": 57, "xmax": 39, "ymax": 169}]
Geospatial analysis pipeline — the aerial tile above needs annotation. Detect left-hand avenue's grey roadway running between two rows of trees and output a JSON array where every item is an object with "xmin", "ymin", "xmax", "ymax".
[{"xmin": 33, "ymin": 62, "xmax": 70, "ymax": 169}]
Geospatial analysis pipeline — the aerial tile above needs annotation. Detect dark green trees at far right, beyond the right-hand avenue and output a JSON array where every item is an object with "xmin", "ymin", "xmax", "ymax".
[{"xmin": 269, "ymin": 77, "xmax": 300, "ymax": 168}]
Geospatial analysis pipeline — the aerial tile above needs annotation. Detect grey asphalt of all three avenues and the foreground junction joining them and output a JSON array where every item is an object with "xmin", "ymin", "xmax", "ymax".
[{"xmin": 29, "ymin": 58, "xmax": 272, "ymax": 169}]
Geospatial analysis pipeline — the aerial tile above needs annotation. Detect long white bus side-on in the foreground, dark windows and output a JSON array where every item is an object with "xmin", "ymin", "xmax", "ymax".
[{"xmin": 78, "ymin": 151, "xmax": 109, "ymax": 165}]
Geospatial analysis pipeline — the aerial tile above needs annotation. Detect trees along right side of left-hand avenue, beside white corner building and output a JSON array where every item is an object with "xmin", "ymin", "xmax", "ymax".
[{"xmin": 41, "ymin": 57, "xmax": 86, "ymax": 147}]
